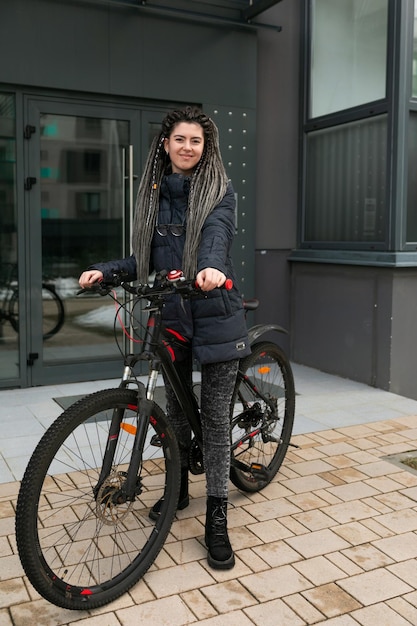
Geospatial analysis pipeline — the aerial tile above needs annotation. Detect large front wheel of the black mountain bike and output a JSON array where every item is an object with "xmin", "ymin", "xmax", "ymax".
[{"xmin": 16, "ymin": 389, "xmax": 180, "ymax": 610}]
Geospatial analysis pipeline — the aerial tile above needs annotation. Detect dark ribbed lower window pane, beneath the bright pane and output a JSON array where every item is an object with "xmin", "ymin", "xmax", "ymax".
[{"xmin": 304, "ymin": 115, "xmax": 387, "ymax": 242}]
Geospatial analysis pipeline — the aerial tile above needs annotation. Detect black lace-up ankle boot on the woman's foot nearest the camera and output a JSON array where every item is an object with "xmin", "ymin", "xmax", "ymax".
[{"xmin": 205, "ymin": 496, "xmax": 235, "ymax": 569}]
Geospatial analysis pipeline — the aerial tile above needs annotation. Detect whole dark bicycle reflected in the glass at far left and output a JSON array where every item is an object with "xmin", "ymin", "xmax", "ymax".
[{"xmin": 0, "ymin": 263, "xmax": 65, "ymax": 340}]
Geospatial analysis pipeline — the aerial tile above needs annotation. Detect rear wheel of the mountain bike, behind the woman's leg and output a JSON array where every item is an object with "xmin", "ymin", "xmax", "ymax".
[{"xmin": 230, "ymin": 341, "xmax": 295, "ymax": 492}]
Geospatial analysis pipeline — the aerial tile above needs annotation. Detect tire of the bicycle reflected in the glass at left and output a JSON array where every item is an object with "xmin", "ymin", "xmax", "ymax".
[{"xmin": 8, "ymin": 283, "xmax": 65, "ymax": 341}]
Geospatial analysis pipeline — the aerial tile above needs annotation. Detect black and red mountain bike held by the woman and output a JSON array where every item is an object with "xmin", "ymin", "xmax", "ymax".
[{"xmin": 16, "ymin": 272, "xmax": 295, "ymax": 609}]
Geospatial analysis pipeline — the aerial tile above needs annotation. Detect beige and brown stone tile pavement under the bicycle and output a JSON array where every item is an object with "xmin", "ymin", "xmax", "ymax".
[{"xmin": 0, "ymin": 364, "xmax": 417, "ymax": 626}]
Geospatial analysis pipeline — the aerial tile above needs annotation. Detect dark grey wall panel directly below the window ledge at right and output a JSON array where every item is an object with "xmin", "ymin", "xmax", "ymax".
[{"xmin": 291, "ymin": 263, "xmax": 392, "ymax": 389}]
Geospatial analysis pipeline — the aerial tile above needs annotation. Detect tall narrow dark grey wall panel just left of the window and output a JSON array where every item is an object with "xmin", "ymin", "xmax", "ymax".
[{"xmin": 256, "ymin": 0, "xmax": 301, "ymax": 250}]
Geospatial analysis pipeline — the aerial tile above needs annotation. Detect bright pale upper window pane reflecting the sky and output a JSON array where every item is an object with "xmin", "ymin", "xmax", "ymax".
[{"xmin": 309, "ymin": 0, "xmax": 388, "ymax": 117}]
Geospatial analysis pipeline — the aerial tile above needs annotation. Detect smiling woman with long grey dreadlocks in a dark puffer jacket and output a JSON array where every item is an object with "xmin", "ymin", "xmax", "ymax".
[{"xmin": 79, "ymin": 107, "xmax": 250, "ymax": 569}]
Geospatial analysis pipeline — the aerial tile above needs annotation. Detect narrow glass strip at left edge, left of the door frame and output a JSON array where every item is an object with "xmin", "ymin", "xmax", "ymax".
[{"xmin": 0, "ymin": 93, "xmax": 19, "ymax": 381}]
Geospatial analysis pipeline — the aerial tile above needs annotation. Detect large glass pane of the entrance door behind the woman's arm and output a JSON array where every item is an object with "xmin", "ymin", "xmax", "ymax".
[{"xmin": 25, "ymin": 98, "xmax": 140, "ymax": 385}]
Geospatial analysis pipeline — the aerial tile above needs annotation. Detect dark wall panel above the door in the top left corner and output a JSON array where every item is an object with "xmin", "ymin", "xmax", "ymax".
[{"xmin": 0, "ymin": 0, "xmax": 109, "ymax": 92}]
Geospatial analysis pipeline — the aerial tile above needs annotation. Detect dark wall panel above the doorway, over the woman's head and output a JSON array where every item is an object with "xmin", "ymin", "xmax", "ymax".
[{"xmin": 109, "ymin": 11, "xmax": 256, "ymax": 108}]
